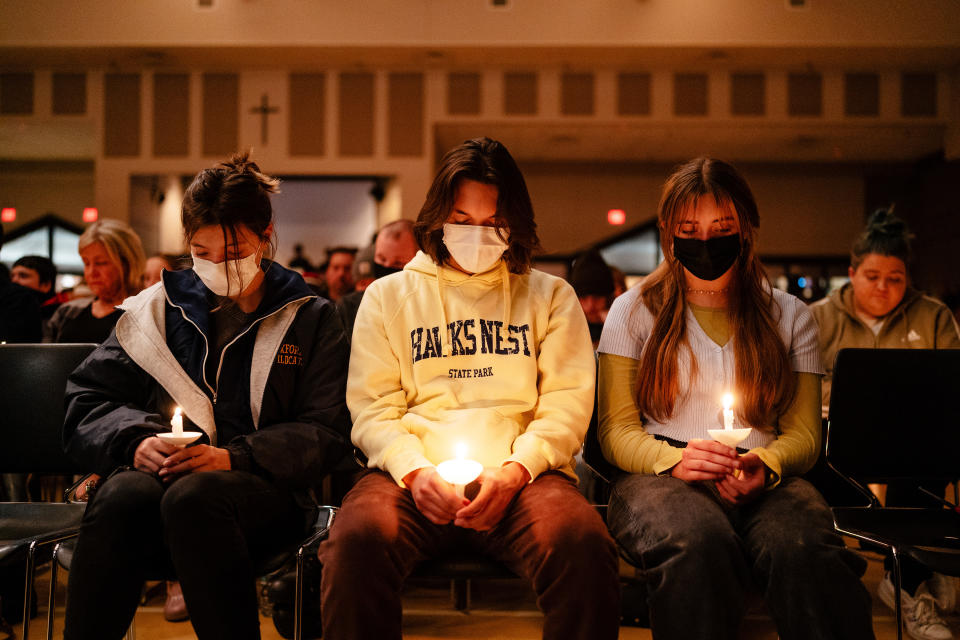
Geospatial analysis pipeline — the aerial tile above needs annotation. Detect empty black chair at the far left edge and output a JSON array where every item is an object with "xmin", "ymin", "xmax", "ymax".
[{"xmin": 0, "ymin": 344, "xmax": 96, "ymax": 638}]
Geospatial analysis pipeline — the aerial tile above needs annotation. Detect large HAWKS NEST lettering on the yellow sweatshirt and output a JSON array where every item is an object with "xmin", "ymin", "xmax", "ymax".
[{"xmin": 410, "ymin": 318, "xmax": 531, "ymax": 362}]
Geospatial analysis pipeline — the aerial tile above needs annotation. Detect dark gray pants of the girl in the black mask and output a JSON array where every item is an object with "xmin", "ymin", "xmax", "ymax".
[{"xmin": 608, "ymin": 475, "xmax": 874, "ymax": 640}]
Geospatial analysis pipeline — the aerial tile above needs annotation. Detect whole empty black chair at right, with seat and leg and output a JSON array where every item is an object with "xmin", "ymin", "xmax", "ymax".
[{"xmin": 827, "ymin": 349, "xmax": 960, "ymax": 638}]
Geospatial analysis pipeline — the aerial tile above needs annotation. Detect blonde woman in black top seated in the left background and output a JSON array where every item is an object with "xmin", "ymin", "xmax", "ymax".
[{"xmin": 44, "ymin": 219, "xmax": 146, "ymax": 343}]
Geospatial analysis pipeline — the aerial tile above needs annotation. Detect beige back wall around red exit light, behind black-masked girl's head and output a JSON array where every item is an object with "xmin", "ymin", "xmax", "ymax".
[{"xmin": 521, "ymin": 163, "xmax": 864, "ymax": 256}]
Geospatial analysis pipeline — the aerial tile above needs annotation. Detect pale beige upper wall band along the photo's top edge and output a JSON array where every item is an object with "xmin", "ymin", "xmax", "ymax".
[{"xmin": 0, "ymin": 0, "xmax": 958, "ymax": 47}]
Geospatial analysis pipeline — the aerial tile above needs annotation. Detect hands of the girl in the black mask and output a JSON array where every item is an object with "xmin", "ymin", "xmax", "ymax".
[{"xmin": 670, "ymin": 440, "xmax": 766, "ymax": 505}]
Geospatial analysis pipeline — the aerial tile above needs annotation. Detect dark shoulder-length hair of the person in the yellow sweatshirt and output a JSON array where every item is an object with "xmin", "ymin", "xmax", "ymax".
[{"xmin": 413, "ymin": 138, "xmax": 540, "ymax": 273}]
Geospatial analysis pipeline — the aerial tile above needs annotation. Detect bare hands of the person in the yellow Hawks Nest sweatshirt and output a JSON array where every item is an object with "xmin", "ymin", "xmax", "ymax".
[{"xmin": 404, "ymin": 462, "xmax": 530, "ymax": 531}]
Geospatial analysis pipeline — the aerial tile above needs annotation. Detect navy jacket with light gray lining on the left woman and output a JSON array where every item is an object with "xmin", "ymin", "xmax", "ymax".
[{"xmin": 63, "ymin": 263, "xmax": 350, "ymax": 489}]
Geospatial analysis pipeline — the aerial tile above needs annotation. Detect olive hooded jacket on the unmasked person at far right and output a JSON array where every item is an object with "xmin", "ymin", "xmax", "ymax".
[{"xmin": 810, "ymin": 283, "xmax": 960, "ymax": 407}]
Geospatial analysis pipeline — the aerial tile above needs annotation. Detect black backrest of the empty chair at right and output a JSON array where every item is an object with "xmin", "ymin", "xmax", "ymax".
[{"xmin": 827, "ymin": 349, "xmax": 960, "ymax": 483}]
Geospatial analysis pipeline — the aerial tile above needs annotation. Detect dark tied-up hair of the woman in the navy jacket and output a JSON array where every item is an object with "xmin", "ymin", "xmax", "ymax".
[{"xmin": 180, "ymin": 151, "xmax": 280, "ymax": 256}]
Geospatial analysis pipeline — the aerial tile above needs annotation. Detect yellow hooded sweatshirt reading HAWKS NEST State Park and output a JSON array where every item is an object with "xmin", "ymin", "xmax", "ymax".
[{"xmin": 347, "ymin": 252, "xmax": 596, "ymax": 486}]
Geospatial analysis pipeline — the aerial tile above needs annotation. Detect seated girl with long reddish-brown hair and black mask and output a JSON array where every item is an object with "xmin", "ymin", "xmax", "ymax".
[{"xmin": 599, "ymin": 158, "xmax": 873, "ymax": 639}]
